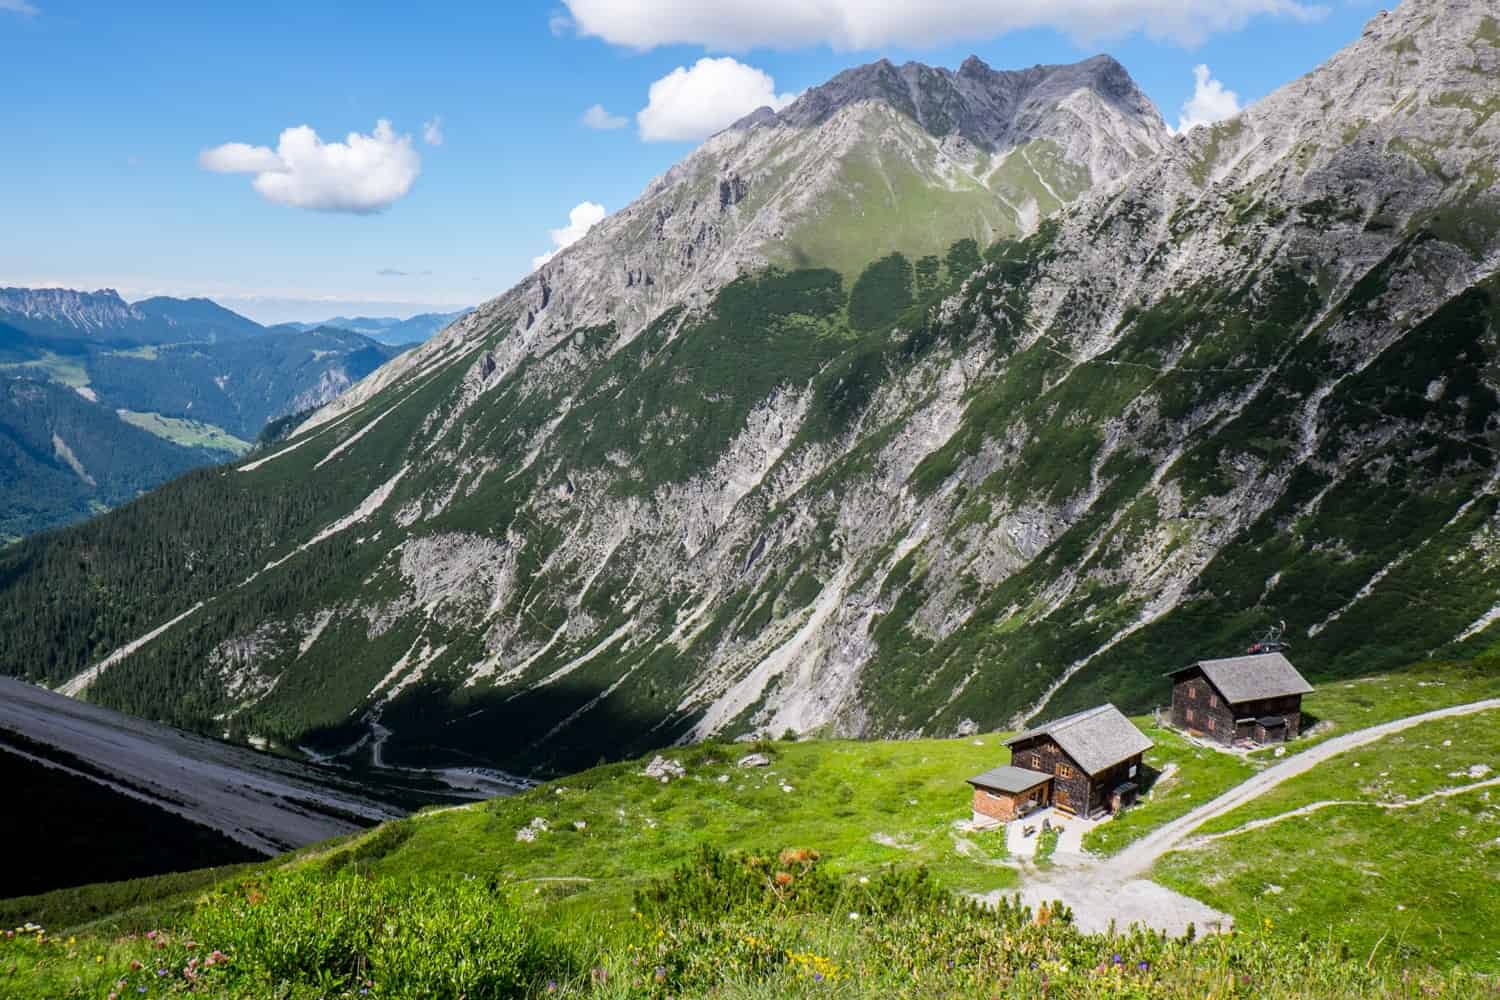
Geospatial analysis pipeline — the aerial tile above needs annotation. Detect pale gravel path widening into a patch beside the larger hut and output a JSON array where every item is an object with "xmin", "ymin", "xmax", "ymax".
[{"xmin": 984, "ymin": 699, "xmax": 1500, "ymax": 934}]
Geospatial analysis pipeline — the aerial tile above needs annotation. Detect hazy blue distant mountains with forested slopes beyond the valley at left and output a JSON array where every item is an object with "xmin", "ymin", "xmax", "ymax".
[{"xmin": 0, "ymin": 288, "xmax": 416, "ymax": 541}]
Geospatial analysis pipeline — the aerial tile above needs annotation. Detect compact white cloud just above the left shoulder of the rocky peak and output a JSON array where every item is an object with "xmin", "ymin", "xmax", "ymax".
[{"xmin": 636, "ymin": 55, "xmax": 797, "ymax": 142}]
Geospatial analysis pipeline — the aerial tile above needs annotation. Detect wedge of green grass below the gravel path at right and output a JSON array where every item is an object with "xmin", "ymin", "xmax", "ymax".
[{"xmin": 1155, "ymin": 712, "xmax": 1500, "ymax": 973}]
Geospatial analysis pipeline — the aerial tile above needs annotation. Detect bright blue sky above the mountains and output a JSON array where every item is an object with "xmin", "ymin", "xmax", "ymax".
[{"xmin": 0, "ymin": 0, "xmax": 1377, "ymax": 321}]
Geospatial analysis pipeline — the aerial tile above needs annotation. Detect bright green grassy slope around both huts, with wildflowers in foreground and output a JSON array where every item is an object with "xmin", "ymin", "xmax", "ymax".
[{"xmin": 0, "ymin": 661, "xmax": 1500, "ymax": 997}]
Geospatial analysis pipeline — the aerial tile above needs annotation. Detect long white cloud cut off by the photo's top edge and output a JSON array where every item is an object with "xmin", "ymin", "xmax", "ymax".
[{"xmin": 566, "ymin": 0, "xmax": 1326, "ymax": 51}]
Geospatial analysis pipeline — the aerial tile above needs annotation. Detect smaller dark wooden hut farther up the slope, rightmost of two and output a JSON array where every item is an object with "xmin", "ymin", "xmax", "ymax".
[{"xmin": 1167, "ymin": 652, "xmax": 1313, "ymax": 745}]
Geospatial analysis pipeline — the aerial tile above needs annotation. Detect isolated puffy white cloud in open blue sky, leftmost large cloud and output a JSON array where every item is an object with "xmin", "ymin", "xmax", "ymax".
[{"xmin": 198, "ymin": 118, "xmax": 422, "ymax": 214}]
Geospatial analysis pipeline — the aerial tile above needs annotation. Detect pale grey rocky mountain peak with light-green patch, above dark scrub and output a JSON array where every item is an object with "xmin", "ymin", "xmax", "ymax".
[{"xmin": 304, "ymin": 48, "xmax": 1172, "ymax": 431}]
